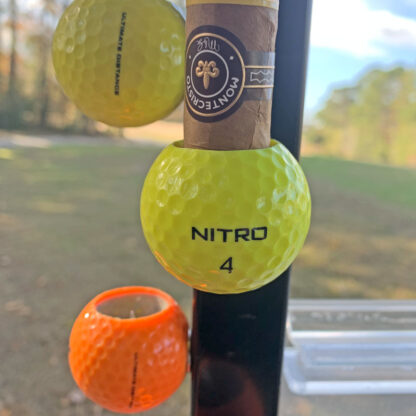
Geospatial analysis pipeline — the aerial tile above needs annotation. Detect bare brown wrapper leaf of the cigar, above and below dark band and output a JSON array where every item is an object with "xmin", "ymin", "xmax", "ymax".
[{"xmin": 184, "ymin": 4, "xmax": 278, "ymax": 150}]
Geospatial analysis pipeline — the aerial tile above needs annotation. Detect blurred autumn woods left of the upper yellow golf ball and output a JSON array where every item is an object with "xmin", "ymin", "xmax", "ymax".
[{"xmin": 0, "ymin": 0, "xmax": 99, "ymax": 133}]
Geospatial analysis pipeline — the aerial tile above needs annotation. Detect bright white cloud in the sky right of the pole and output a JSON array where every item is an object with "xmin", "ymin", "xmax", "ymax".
[{"xmin": 311, "ymin": 0, "xmax": 416, "ymax": 56}]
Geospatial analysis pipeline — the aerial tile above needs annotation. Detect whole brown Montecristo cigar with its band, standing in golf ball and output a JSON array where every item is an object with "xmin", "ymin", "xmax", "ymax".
[{"xmin": 184, "ymin": 0, "xmax": 279, "ymax": 150}]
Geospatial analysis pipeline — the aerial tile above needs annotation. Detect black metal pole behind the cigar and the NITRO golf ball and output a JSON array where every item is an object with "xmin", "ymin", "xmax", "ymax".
[{"xmin": 191, "ymin": 0, "xmax": 312, "ymax": 416}]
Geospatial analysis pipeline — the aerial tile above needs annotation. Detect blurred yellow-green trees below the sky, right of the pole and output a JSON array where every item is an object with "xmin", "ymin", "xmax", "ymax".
[{"xmin": 306, "ymin": 67, "xmax": 416, "ymax": 164}]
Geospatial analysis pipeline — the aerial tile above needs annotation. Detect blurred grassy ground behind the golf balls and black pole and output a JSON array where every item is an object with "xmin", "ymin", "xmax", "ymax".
[{"xmin": 0, "ymin": 146, "xmax": 416, "ymax": 416}]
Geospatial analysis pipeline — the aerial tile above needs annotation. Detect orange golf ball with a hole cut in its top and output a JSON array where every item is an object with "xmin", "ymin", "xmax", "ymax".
[{"xmin": 69, "ymin": 287, "xmax": 188, "ymax": 413}]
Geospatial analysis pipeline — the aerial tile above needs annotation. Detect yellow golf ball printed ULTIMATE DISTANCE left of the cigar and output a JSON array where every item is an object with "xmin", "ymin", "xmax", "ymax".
[{"xmin": 52, "ymin": 0, "xmax": 185, "ymax": 127}]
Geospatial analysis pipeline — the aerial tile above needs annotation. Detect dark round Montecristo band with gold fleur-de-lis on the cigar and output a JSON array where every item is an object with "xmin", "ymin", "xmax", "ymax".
[{"xmin": 185, "ymin": 26, "xmax": 275, "ymax": 123}]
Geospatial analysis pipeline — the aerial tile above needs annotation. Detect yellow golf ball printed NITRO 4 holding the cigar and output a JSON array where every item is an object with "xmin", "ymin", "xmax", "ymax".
[{"xmin": 141, "ymin": 141, "xmax": 311, "ymax": 294}]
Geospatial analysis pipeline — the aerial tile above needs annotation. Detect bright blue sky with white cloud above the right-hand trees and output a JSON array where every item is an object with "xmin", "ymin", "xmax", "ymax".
[{"xmin": 306, "ymin": 0, "xmax": 416, "ymax": 117}]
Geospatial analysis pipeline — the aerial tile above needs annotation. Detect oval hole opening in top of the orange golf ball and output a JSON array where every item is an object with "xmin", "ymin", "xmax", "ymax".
[{"xmin": 97, "ymin": 294, "xmax": 168, "ymax": 319}]
